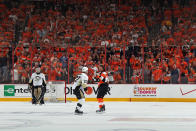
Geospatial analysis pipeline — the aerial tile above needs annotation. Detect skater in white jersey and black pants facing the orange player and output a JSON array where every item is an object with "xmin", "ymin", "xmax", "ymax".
[{"xmin": 72, "ymin": 67, "xmax": 88, "ymax": 114}]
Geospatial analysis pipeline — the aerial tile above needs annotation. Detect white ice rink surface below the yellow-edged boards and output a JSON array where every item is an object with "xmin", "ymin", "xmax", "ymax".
[{"xmin": 0, "ymin": 102, "xmax": 196, "ymax": 131}]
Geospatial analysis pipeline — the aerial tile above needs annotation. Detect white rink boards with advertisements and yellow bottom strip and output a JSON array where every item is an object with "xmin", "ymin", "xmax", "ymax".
[{"xmin": 0, "ymin": 84, "xmax": 196, "ymax": 102}]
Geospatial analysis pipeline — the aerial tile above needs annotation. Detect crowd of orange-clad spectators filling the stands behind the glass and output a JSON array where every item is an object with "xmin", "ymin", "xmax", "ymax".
[{"xmin": 0, "ymin": 0, "xmax": 196, "ymax": 84}]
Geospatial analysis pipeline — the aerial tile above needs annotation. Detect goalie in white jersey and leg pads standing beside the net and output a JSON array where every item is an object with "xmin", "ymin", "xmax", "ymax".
[{"xmin": 28, "ymin": 67, "xmax": 46, "ymax": 105}]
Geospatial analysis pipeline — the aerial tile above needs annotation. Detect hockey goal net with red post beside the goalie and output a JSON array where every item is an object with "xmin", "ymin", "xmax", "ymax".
[{"xmin": 44, "ymin": 81, "xmax": 67, "ymax": 103}]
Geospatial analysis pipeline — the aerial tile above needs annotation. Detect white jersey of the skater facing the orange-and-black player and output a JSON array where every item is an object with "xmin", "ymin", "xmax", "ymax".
[{"xmin": 72, "ymin": 73, "xmax": 88, "ymax": 90}]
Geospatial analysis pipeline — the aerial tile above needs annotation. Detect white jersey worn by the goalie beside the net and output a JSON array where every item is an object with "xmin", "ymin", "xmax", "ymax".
[{"xmin": 30, "ymin": 73, "xmax": 46, "ymax": 86}]
